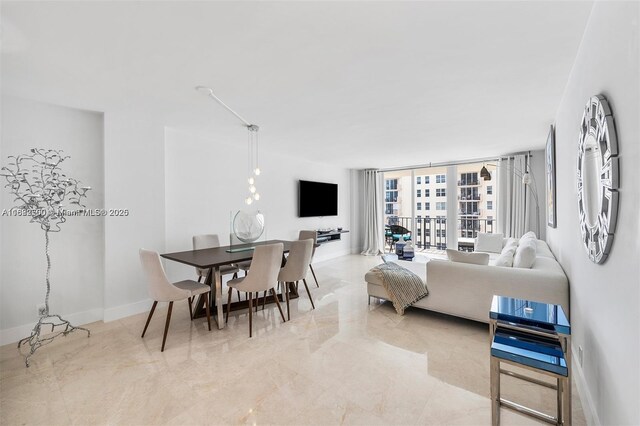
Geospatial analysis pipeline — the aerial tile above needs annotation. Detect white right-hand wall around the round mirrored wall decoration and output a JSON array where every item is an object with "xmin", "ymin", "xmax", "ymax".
[{"xmin": 547, "ymin": 2, "xmax": 640, "ymax": 425}]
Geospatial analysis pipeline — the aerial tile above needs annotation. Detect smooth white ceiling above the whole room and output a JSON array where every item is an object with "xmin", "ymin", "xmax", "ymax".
[{"xmin": 1, "ymin": 1, "xmax": 592, "ymax": 168}]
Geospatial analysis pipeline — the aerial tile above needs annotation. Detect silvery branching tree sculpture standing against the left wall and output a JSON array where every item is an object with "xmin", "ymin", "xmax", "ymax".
[{"xmin": 0, "ymin": 148, "xmax": 91, "ymax": 367}]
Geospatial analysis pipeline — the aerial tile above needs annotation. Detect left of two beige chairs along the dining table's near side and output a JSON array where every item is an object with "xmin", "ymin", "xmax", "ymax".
[{"xmin": 225, "ymin": 243, "xmax": 285, "ymax": 337}]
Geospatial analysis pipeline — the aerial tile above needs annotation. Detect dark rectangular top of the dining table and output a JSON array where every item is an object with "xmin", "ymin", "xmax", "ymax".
[{"xmin": 160, "ymin": 240, "xmax": 291, "ymax": 269}]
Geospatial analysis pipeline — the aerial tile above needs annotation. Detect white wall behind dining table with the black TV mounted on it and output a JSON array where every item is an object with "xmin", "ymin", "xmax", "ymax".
[{"xmin": 165, "ymin": 128, "xmax": 351, "ymax": 279}]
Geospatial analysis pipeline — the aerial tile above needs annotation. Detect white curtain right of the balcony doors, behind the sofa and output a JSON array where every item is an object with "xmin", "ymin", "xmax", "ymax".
[{"xmin": 496, "ymin": 155, "xmax": 531, "ymax": 238}]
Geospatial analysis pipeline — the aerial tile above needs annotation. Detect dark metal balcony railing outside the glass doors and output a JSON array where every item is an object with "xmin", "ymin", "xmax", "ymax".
[{"xmin": 387, "ymin": 216, "xmax": 495, "ymax": 250}]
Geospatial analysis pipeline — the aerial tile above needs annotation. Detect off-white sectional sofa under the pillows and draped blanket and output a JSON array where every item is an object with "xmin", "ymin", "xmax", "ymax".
[{"xmin": 365, "ymin": 240, "xmax": 570, "ymax": 322}]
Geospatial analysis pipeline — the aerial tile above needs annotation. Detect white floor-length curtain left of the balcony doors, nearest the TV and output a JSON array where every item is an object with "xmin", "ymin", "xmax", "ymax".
[{"xmin": 362, "ymin": 170, "xmax": 384, "ymax": 256}]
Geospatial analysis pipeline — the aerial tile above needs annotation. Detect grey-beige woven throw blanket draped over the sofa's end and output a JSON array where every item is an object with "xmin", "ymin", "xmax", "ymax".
[{"xmin": 374, "ymin": 263, "xmax": 429, "ymax": 315}]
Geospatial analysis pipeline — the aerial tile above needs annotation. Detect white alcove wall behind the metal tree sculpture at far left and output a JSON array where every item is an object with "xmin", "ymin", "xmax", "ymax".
[{"xmin": 0, "ymin": 96, "xmax": 104, "ymax": 342}]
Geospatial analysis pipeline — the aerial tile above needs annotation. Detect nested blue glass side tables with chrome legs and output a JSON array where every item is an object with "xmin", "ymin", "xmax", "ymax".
[{"xmin": 489, "ymin": 296, "xmax": 571, "ymax": 426}]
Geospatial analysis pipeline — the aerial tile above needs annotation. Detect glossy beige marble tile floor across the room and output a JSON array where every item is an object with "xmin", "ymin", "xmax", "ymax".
[{"xmin": 0, "ymin": 255, "xmax": 585, "ymax": 425}]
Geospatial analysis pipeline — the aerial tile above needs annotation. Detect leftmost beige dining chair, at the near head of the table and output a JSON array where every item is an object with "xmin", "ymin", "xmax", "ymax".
[{"xmin": 139, "ymin": 249, "xmax": 211, "ymax": 352}]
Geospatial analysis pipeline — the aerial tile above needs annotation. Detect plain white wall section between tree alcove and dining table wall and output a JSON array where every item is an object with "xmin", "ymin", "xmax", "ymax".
[{"xmin": 104, "ymin": 109, "xmax": 165, "ymax": 321}]
